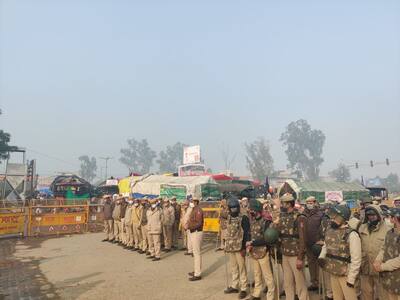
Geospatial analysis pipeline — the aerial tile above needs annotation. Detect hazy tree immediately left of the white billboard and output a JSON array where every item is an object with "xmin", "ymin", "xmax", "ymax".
[{"xmin": 157, "ymin": 142, "xmax": 186, "ymax": 173}]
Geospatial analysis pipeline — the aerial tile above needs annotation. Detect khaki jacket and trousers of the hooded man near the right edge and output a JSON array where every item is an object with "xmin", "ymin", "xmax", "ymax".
[{"xmin": 359, "ymin": 205, "xmax": 390, "ymax": 300}]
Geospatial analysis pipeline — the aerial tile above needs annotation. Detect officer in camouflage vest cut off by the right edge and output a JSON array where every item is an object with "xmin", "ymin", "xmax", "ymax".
[{"xmin": 374, "ymin": 208, "xmax": 400, "ymax": 300}]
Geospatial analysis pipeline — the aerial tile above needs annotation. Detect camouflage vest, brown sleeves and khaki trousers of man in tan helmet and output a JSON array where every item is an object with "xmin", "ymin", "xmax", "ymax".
[{"xmin": 278, "ymin": 211, "xmax": 309, "ymax": 300}]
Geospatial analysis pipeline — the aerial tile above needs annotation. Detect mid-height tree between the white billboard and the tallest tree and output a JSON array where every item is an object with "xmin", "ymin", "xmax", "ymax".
[{"xmin": 244, "ymin": 137, "xmax": 274, "ymax": 181}]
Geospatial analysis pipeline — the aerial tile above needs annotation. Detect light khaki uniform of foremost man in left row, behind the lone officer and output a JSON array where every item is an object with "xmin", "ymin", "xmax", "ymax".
[{"xmin": 147, "ymin": 207, "xmax": 162, "ymax": 258}]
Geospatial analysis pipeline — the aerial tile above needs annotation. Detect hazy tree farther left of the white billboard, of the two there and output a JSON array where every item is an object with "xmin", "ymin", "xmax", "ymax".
[{"xmin": 119, "ymin": 138, "xmax": 157, "ymax": 174}]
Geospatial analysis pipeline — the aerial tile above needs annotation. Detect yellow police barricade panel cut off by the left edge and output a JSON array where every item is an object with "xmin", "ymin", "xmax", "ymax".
[{"xmin": 0, "ymin": 207, "xmax": 26, "ymax": 236}]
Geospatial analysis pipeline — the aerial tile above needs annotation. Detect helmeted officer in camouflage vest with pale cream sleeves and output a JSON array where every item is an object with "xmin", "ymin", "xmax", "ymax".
[{"xmin": 318, "ymin": 205, "xmax": 361, "ymax": 300}]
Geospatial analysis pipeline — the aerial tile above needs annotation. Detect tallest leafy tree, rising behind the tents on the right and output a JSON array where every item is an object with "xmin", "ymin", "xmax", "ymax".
[{"xmin": 280, "ymin": 119, "xmax": 325, "ymax": 180}]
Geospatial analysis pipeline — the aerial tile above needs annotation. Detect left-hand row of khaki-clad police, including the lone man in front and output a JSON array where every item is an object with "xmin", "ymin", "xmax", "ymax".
[{"xmin": 103, "ymin": 195, "xmax": 204, "ymax": 281}]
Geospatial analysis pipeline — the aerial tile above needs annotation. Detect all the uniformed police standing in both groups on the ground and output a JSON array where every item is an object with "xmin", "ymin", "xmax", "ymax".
[{"xmin": 100, "ymin": 193, "xmax": 400, "ymax": 300}]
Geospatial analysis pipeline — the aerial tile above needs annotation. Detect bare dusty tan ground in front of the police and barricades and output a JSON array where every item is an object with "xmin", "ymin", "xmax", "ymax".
[{"xmin": 0, "ymin": 233, "xmax": 318, "ymax": 300}]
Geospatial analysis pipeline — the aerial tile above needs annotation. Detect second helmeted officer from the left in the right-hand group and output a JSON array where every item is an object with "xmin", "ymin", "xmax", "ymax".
[{"xmin": 246, "ymin": 199, "xmax": 275, "ymax": 300}]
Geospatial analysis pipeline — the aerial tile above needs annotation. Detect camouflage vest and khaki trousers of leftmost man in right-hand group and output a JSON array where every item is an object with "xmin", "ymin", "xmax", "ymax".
[{"xmin": 225, "ymin": 215, "xmax": 247, "ymax": 291}]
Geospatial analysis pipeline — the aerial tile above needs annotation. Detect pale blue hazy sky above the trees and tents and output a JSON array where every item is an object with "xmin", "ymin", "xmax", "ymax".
[{"xmin": 0, "ymin": 0, "xmax": 400, "ymax": 177}]
